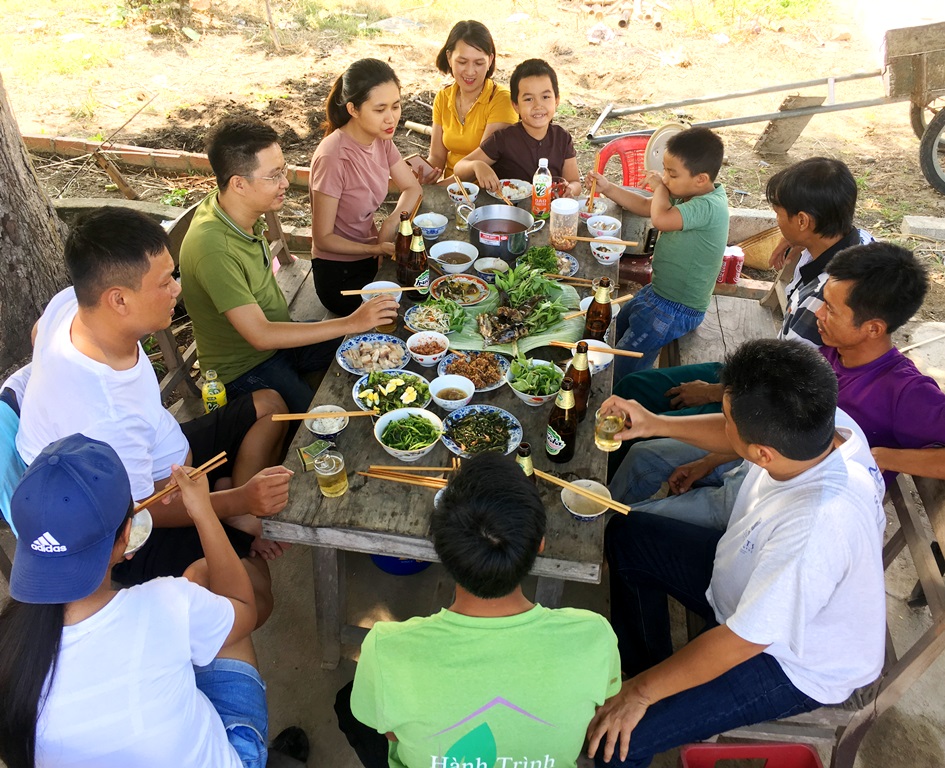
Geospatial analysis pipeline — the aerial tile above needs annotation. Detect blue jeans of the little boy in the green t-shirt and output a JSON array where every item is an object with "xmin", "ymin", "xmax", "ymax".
[{"xmin": 614, "ymin": 285, "xmax": 705, "ymax": 381}]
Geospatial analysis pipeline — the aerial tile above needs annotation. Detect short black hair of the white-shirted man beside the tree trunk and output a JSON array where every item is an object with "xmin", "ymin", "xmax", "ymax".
[{"xmin": 65, "ymin": 206, "xmax": 170, "ymax": 307}]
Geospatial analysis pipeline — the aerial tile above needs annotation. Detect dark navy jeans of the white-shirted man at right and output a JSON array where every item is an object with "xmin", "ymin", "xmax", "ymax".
[{"xmin": 596, "ymin": 512, "xmax": 821, "ymax": 768}]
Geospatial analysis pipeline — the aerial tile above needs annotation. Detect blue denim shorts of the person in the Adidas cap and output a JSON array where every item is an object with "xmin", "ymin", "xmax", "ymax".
[{"xmin": 194, "ymin": 659, "xmax": 269, "ymax": 768}]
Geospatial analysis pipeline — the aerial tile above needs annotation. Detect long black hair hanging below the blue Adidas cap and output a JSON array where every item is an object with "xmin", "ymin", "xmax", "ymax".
[{"xmin": 0, "ymin": 506, "xmax": 134, "ymax": 768}]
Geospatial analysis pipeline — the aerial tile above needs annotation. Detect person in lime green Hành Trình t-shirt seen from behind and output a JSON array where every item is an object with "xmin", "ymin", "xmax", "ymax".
[{"xmin": 335, "ymin": 454, "xmax": 620, "ymax": 768}]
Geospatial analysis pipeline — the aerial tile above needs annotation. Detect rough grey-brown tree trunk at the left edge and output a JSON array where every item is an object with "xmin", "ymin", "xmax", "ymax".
[{"xmin": 0, "ymin": 77, "xmax": 69, "ymax": 371}]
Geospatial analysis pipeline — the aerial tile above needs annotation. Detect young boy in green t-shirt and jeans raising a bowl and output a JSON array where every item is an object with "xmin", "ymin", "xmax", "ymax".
[{"xmin": 589, "ymin": 128, "xmax": 728, "ymax": 381}]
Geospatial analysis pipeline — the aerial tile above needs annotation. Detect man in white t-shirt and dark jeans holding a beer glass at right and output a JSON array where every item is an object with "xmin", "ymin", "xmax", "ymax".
[{"xmin": 588, "ymin": 340, "xmax": 886, "ymax": 768}]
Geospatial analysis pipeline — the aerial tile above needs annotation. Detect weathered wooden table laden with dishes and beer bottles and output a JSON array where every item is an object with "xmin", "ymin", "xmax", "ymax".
[{"xmin": 263, "ymin": 188, "xmax": 619, "ymax": 669}]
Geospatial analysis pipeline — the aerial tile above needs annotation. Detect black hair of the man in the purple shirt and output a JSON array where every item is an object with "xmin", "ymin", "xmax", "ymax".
[{"xmin": 824, "ymin": 241, "xmax": 929, "ymax": 333}]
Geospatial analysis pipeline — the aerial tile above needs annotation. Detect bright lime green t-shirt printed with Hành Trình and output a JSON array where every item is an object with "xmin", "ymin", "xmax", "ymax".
[{"xmin": 351, "ymin": 605, "xmax": 620, "ymax": 768}]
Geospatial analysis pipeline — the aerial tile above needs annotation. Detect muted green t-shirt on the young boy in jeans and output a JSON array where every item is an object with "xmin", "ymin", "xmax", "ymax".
[{"xmin": 653, "ymin": 184, "xmax": 728, "ymax": 312}]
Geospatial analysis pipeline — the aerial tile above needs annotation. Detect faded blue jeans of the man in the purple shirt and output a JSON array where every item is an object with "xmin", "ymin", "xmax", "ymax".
[{"xmin": 610, "ymin": 438, "xmax": 750, "ymax": 531}]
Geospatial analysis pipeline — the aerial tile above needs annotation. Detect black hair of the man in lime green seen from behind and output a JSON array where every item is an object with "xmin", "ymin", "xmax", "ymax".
[{"xmin": 430, "ymin": 453, "xmax": 545, "ymax": 600}]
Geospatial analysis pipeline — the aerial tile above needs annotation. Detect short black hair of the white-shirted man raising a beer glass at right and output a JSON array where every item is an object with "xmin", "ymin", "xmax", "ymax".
[{"xmin": 720, "ymin": 339, "xmax": 837, "ymax": 461}]
